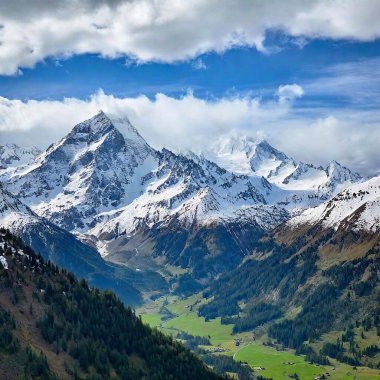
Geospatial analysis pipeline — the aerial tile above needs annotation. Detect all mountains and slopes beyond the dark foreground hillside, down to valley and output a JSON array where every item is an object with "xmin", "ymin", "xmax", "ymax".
[{"xmin": 0, "ymin": 111, "xmax": 380, "ymax": 374}]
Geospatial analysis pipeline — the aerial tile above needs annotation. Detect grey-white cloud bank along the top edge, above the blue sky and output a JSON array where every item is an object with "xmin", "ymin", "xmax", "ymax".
[{"xmin": 0, "ymin": 0, "xmax": 380, "ymax": 75}]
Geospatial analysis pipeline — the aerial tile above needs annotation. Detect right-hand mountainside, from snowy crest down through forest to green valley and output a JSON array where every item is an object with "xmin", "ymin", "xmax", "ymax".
[{"xmin": 200, "ymin": 177, "xmax": 380, "ymax": 366}]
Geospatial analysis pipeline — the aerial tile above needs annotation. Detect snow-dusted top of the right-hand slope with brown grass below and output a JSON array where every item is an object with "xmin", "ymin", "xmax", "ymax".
[{"xmin": 274, "ymin": 176, "xmax": 380, "ymax": 267}]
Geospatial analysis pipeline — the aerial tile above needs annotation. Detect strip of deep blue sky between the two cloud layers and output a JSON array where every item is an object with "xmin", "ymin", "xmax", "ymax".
[{"xmin": 0, "ymin": 33, "xmax": 380, "ymax": 107}]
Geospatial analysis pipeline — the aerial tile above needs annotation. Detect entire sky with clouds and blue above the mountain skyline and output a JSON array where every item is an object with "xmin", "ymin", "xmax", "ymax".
[{"xmin": 0, "ymin": 0, "xmax": 380, "ymax": 176}]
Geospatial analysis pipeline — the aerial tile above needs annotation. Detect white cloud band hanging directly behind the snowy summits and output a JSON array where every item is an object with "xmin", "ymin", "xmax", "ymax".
[{"xmin": 0, "ymin": 87, "xmax": 380, "ymax": 174}]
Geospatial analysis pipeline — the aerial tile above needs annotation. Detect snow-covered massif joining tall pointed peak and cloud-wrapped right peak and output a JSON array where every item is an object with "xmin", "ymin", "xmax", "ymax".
[{"xmin": 2, "ymin": 111, "xmax": 372, "ymax": 264}]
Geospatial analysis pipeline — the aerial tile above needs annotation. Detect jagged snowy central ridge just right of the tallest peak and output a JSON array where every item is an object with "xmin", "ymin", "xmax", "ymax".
[{"xmin": 87, "ymin": 145, "xmax": 288, "ymax": 246}]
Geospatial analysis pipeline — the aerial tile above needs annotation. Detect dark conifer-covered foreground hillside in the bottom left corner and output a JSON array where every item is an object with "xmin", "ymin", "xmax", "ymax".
[{"xmin": 0, "ymin": 230, "xmax": 223, "ymax": 380}]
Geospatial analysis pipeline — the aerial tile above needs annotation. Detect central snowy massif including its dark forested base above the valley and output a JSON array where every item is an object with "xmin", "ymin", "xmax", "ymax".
[{"xmin": 0, "ymin": 111, "xmax": 374, "ymax": 290}]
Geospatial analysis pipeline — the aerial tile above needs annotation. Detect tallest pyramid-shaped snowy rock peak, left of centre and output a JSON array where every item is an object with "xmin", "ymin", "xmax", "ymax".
[{"xmin": 0, "ymin": 111, "xmax": 156, "ymax": 230}]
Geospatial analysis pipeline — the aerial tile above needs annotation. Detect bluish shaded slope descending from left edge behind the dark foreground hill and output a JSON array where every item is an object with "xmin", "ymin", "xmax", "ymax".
[{"xmin": 0, "ymin": 187, "xmax": 166, "ymax": 304}]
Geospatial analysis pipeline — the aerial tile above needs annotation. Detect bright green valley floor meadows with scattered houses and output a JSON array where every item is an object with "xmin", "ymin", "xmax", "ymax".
[{"xmin": 136, "ymin": 294, "xmax": 380, "ymax": 380}]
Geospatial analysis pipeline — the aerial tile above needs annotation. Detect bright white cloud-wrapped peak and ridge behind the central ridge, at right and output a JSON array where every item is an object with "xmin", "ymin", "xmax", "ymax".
[{"xmin": 204, "ymin": 136, "xmax": 362, "ymax": 205}]
